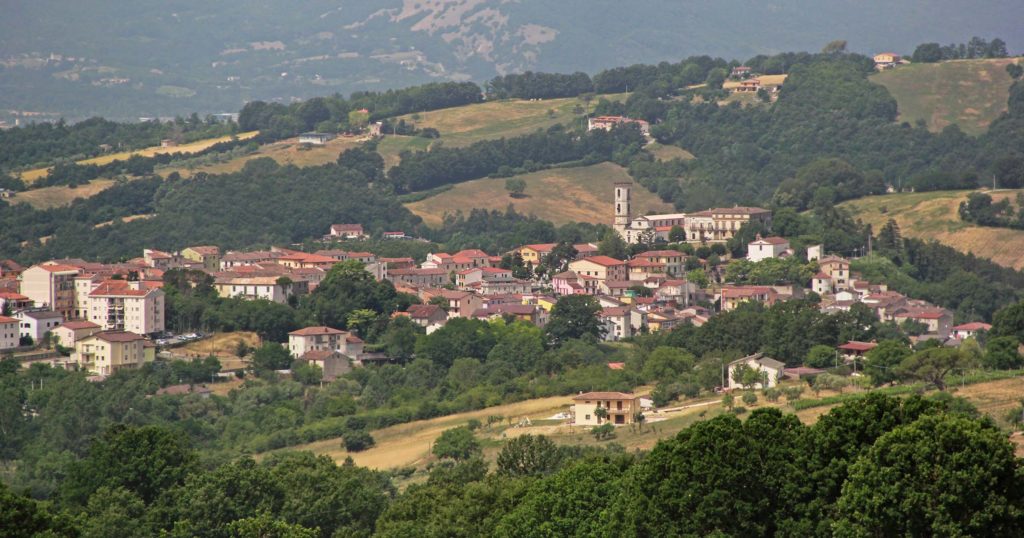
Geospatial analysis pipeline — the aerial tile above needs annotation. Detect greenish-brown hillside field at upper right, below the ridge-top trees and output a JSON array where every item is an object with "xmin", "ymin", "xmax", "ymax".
[{"xmin": 870, "ymin": 58, "xmax": 1019, "ymax": 134}]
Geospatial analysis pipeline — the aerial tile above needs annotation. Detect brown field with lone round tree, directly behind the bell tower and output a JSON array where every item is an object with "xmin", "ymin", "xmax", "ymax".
[{"xmin": 406, "ymin": 163, "xmax": 675, "ymax": 226}]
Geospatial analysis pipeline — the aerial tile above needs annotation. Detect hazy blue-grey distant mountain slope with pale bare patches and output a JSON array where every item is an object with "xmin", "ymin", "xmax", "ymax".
[{"xmin": 6, "ymin": 0, "xmax": 1024, "ymax": 118}]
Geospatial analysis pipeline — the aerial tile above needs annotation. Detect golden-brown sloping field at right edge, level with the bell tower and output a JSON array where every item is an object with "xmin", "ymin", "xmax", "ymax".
[{"xmin": 841, "ymin": 190, "xmax": 1024, "ymax": 270}]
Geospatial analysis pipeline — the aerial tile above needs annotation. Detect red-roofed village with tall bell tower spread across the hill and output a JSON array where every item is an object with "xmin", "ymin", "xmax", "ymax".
[{"xmin": 0, "ymin": 183, "xmax": 974, "ymax": 387}]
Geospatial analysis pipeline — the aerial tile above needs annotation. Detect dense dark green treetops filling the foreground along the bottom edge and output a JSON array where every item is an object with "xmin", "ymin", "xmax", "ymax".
[{"xmin": 0, "ymin": 395, "xmax": 1024, "ymax": 538}]
